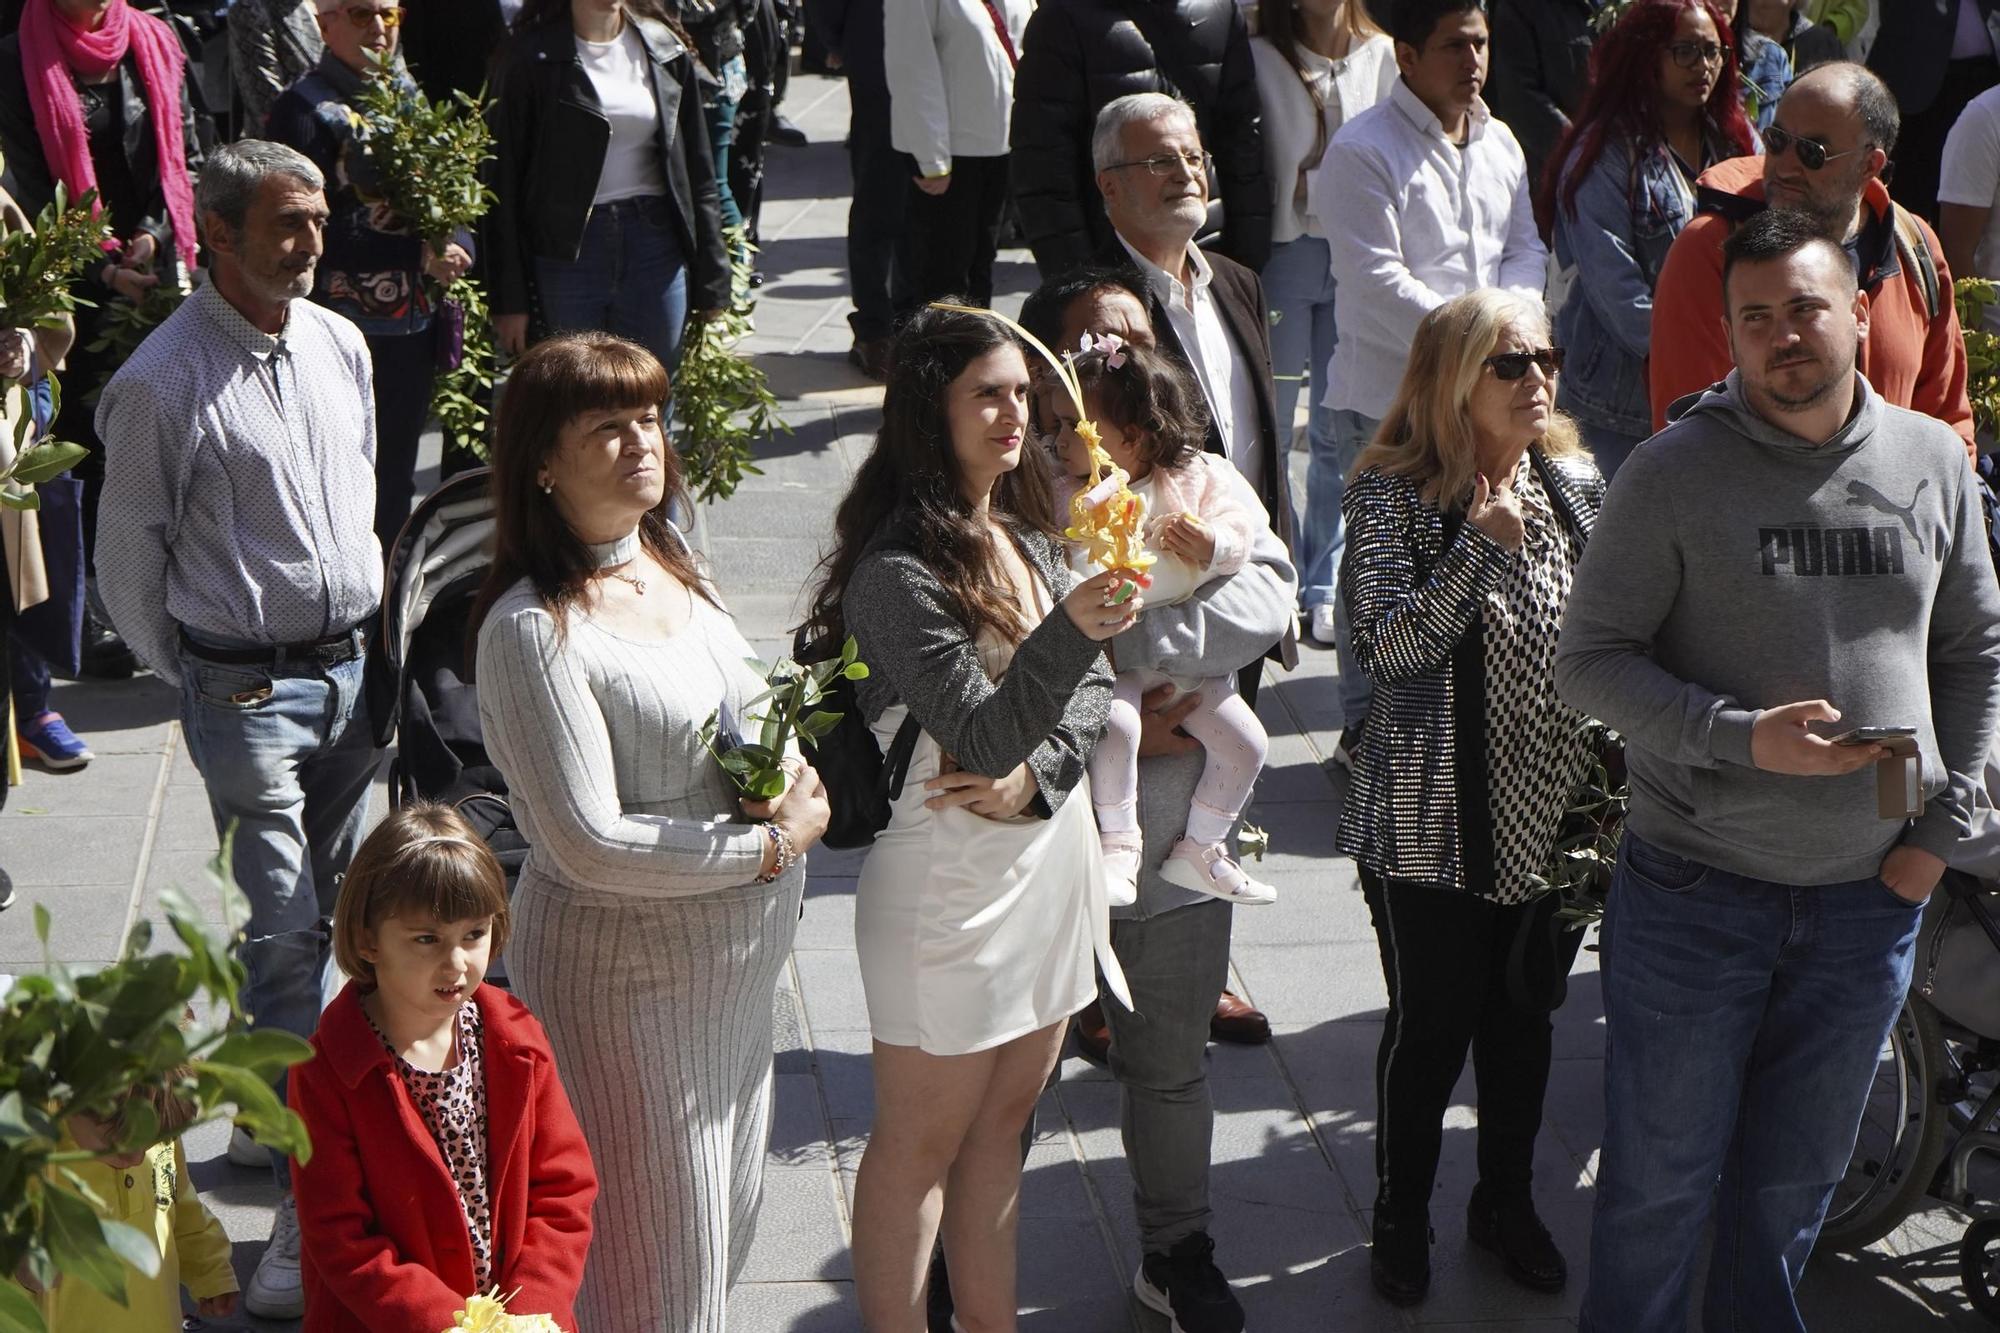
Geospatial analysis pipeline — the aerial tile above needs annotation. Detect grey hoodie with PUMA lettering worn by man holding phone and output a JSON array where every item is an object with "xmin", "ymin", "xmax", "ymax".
[{"xmin": 1556, "ymin": 372, "xmax": 2000, "ymax": 885}]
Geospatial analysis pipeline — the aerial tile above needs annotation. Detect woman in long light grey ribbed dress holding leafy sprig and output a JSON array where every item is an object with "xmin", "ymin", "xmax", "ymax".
[{"xmin": 476, "ymin": 334, "xmax": 826, "ymax": 1333}]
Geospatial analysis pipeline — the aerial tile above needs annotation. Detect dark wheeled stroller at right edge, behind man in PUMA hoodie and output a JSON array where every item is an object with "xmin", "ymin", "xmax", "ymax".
[{"xmin": 1820, "ymin": 871, "xmax": 2000, "ymax": 1323}]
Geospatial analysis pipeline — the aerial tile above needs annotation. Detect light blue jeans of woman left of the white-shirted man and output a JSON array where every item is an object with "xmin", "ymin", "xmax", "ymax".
[{"xmin": 1264, "ymin": 236, "xmax": 1354, "ymax": 610}]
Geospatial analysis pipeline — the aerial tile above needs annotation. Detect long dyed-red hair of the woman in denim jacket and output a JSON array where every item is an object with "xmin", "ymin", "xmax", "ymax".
[{"xmin": 1534, "ymin": 0, "xmax": 1756, "ymax": 232}]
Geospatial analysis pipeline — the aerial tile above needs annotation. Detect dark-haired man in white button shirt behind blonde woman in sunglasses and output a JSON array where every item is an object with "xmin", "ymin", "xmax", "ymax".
[{"xmin": 1306, "ymin": 0, "xmax": 1548, "ymax": 763}]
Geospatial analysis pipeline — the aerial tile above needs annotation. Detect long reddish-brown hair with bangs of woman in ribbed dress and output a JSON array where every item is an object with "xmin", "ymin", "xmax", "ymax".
[{"xmin": 470, "ymin": 332, "xmax": 714, "ymax": 634}]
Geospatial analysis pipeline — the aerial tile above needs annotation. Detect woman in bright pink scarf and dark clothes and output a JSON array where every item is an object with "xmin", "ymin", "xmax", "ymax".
[{"xmin": 0, "ymin": 0, "xmax": 200, "ymax": 677}]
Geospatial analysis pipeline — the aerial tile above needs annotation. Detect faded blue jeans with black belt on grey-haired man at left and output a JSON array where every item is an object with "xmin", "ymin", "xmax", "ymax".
[{"xmin": 180, "ymin": 648, "xmax": 382, "ymax": 1185}]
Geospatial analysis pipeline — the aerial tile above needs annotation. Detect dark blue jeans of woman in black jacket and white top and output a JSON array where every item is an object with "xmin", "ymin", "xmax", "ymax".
[{"xmin": 534, "ymin": 194, "xmax": 688, "ymax": 370}]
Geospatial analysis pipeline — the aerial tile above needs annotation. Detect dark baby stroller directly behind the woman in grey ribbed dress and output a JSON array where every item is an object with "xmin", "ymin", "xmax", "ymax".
[{"xmin": 376, "ymin": 468, "xmax": 528, "ymax": 964}]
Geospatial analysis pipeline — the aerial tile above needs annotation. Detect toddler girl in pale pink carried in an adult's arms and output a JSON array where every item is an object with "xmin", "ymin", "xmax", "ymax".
[{"xmin": 1054, "ymin": 336, "xmax": 1278, "ymax": 907}]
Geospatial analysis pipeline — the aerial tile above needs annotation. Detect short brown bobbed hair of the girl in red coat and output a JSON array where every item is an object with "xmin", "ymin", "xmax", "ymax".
[{"xmin": 334, "ymin": 801, "xmax": 508, "ymax": 987}]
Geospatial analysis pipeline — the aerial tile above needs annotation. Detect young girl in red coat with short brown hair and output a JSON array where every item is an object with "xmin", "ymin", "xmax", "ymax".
[{"xmin": 290, "ymin": 805, "xmax": 598, "ymax": 1333}]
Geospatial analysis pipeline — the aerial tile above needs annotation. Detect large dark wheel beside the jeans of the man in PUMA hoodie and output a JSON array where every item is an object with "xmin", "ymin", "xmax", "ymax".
[{"xmin": 1820, "ymin": 995, "xmax": 1950, "ymax": 1249}]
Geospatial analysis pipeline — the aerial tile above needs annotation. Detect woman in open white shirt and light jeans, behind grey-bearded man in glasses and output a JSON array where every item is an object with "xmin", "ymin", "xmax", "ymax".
[{"xmin": 1250, "ymin": 0, "xmax": 1396, "ymax": 642}]
